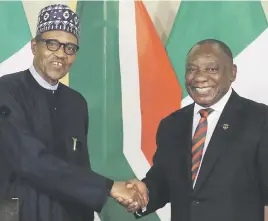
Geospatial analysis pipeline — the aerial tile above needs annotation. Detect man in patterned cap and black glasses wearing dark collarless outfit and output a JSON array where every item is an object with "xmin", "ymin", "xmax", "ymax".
[{"xmin": 0, "ymin": 4, "xmax": 146, "ymax": 221}]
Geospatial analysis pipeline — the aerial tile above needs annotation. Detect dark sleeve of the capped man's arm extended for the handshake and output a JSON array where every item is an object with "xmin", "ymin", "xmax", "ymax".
[{"xmin": 0, "ymin": 87, "xmax": 113, "ymax": 212}]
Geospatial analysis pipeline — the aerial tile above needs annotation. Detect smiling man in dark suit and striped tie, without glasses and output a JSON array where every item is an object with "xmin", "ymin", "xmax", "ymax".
[{"xmin": 125, "ymin": 39, "xmax": 268, "ymax": 221}]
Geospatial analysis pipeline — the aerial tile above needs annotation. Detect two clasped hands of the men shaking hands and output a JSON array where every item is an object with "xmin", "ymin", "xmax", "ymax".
[{"xmin": 110, "ymin": 179, "xmax": 148, "ymax": 213}]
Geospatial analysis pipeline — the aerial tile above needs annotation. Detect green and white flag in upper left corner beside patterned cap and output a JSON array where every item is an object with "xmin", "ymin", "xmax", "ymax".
[{"xmin": 0, "ymin": 1, "xmax": 33, "ymax": 76}]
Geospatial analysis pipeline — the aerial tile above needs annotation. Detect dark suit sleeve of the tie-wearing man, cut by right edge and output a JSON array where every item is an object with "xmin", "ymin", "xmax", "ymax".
[{"xmin": 257, "ymin": 105, "xmax": 268, "ymax": 205}]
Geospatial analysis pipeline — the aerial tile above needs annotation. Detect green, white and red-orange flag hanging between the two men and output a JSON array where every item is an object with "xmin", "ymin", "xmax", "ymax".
[{"xmin": 69, "ymin": 1, "xmax": 181, "ymax": 221}]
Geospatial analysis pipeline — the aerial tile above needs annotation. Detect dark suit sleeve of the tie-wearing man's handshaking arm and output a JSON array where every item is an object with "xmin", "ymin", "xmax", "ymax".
[{"xmin": 135, "ymin": 120, "xmax": 169, "ymax": 218}]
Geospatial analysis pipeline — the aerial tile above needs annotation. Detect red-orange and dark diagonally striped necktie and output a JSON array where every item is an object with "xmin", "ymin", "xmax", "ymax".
[{"xmin": 192, "ymin": 108, "xmax": 213, "ymax": 182}]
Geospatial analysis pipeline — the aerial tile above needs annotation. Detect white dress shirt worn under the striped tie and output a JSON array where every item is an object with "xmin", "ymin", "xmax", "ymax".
[{"xmin": 192, "ymin": 87, "xmax": 232, "ymax": 188}]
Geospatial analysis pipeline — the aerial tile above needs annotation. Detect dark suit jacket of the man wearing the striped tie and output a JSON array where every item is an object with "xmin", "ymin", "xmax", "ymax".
[{"xmin": 137, "ymin": 91, "xmax": 268, "ymax": 221}]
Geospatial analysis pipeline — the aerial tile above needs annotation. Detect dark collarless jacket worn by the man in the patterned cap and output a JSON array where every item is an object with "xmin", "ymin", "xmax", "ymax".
[{"xmin": 0, "ymin": 70, "xmax": 113, "ymax": 221}]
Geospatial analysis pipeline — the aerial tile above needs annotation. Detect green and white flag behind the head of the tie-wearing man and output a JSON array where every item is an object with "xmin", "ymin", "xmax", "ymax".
[{"xmin": 166, "ymin": 1, "xmax": 268, "ymax": 106}]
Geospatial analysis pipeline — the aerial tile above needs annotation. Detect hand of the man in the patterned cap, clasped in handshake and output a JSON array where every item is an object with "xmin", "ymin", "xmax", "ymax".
[{"xmin": 110, "ymin": 182, "xmax": 146, "ymax": 208}]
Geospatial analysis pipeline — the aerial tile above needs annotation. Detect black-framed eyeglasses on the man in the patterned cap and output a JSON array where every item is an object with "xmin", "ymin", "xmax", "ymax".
[{"xmin": 36, "ymin": 38, "xmax": 79, "ymax": 55}]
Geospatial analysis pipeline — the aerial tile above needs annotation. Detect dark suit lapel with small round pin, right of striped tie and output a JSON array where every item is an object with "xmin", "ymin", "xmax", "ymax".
[{"xmin": 194, "ymin": 91, "xmax": 242, "ymax": 193}]
